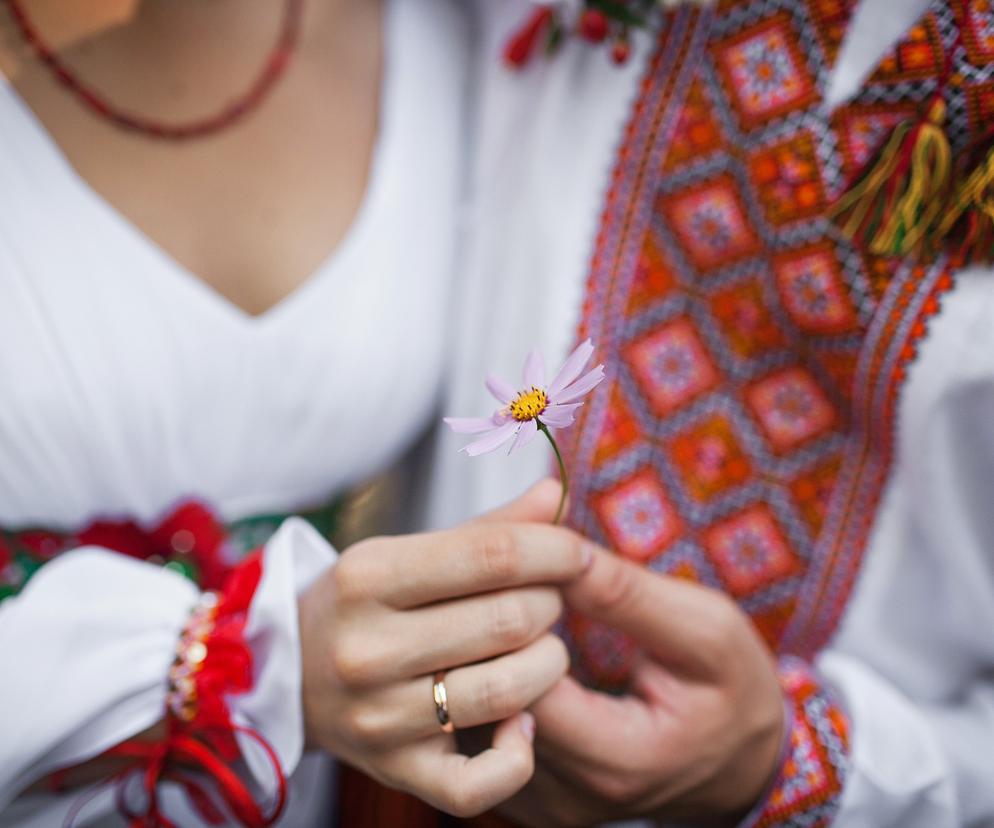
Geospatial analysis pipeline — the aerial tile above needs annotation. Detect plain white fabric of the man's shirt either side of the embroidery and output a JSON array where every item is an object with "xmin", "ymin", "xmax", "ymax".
[{"xmin": 432, "ymin": 0, "xmax": 994, "ymax": 828}]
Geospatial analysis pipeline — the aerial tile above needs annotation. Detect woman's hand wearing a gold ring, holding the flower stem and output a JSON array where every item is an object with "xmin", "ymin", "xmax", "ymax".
[{"xmin": 300, "ymin": 481, "xmax": 591, "ymax": 816}]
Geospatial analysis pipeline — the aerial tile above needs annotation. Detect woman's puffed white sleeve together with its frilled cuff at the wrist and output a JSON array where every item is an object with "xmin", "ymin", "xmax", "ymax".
[{"xmin": 0, "ymin": 518, "xmax": 336, "ymax": 825}]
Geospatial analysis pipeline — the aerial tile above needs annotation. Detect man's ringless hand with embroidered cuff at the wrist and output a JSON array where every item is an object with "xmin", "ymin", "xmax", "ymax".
[{"xmin": 504, "ymin": 550, "xmax": 784, "ymax": 828}]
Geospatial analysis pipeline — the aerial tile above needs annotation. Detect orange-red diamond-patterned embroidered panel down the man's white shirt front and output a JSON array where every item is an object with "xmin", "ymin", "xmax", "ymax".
[{"xmin": 566, "ymin": 0, "xmax": 964, "ymax": 700}]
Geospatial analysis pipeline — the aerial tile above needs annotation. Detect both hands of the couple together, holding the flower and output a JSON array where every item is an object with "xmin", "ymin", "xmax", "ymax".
[{"xmin": 300, "ymin": 482, "xmax": 783, "ymax": 826}]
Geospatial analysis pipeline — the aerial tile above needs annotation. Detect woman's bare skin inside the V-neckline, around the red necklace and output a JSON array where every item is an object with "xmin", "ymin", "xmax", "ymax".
[{"xmin": 1, "ymin": 3, "xmax": 384, "ymax": 314}]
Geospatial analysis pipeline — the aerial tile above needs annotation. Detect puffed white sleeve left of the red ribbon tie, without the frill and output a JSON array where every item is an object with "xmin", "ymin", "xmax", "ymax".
[{"xmin": 0, "ymin": 547, "xmax": 197, "ymax": 810}]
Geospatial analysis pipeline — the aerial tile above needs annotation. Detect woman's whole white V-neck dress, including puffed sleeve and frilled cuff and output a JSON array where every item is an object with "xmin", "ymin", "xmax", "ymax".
[{"xmin": 0, "ymin": 0, "xmax": 466, "ymax": 826}]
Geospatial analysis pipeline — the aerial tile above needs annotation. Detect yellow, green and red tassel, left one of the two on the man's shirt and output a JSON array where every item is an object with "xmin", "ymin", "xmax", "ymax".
[{"xmin": 828, "ymin": 97, "xmax": 952, "ymax": 259}]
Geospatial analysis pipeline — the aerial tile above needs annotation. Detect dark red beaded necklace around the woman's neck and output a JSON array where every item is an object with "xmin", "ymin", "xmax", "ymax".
[{"xmin": 0, "ymin": 0, "xmax": 304, "ymax": 141}]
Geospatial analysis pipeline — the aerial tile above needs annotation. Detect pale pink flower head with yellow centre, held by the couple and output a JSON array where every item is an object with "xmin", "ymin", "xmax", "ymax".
[{"xmin": 445, "ymin": 339, "xmax": 604, "ymax": 457}]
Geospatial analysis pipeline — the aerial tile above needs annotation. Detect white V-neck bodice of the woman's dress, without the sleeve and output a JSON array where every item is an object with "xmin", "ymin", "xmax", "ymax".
[{"xmin": 0, "ymin": 2, "xmax": 465, "ymax": 527}]
